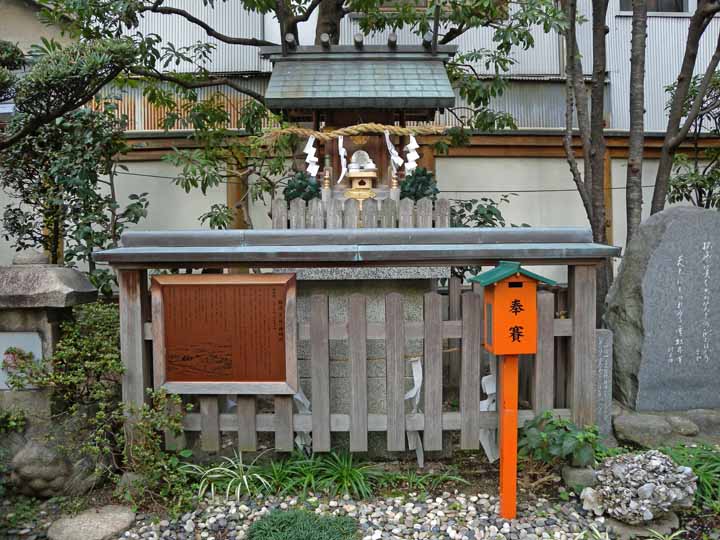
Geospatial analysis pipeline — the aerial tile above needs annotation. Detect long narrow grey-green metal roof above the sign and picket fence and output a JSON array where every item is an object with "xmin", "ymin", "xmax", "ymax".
[{"xmin": 95, "ymin": 227, "xmax": 620, "ymax": 268}]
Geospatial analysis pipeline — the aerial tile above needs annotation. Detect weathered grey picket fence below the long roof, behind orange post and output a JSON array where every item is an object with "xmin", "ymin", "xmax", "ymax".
[{"xmin": 172, "ymin": 288, "xmax": 572, "ymax": 452}]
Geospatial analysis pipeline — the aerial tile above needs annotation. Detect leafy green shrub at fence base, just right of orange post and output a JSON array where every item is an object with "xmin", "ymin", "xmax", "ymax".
[{"xmin": 518, "ymin": 411, "xmax": 600, "ymax": 467}]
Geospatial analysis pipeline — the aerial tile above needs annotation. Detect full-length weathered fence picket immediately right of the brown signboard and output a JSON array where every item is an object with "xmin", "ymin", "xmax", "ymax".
[{"xmin": 310, "ymin": 294, "xmax": 330, "ymax": 452}]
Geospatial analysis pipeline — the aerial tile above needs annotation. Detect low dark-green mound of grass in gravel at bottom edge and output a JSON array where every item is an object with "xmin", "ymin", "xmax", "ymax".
[{"xmin": 248, "ymin": 510, "xmax": 358, "ymax": 540}]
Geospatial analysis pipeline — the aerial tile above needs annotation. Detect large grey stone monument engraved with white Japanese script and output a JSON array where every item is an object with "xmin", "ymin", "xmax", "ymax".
[{"xmin": 605, "ymin": 207, "xmax": 720, "ymax": 411}]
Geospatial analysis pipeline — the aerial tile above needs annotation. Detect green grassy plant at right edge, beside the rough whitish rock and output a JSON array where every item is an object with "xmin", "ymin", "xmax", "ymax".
[{"xmin": 660, "ymin": 444, "xmax": 720, "ymax": 512}]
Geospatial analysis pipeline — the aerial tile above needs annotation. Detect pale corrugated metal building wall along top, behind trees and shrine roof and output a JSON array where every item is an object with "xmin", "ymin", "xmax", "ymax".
[{"xmin": 124, "ymin": 0, "xmax": 720, "ymax": 132}]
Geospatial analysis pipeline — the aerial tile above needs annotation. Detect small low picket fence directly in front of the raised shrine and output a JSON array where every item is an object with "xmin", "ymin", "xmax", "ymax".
[{"xmin": 271, "ymin": 198, "xmax": 450, "ymax": 229}]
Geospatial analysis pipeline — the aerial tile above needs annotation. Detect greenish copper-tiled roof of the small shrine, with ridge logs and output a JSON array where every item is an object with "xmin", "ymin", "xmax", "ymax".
[{"xmin": 261, "ymin": 45, "xmax": 455, "ymax": 111}]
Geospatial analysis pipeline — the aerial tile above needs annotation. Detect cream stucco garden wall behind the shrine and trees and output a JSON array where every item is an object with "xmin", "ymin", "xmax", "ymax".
[{"xmin": 0, "ymin": 157, "xmax": 680, "ymax": 272}]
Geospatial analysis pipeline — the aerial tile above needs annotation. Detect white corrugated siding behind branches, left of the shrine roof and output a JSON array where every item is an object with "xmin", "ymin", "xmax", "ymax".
[{"xmin": 129, "ymin": 0, "xmax": 264, "ymax": 73}]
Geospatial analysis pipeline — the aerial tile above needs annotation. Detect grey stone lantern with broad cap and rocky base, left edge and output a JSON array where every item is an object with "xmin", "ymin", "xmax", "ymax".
[{"xmin": 0, "ymin": 251, "xmax": 97, "ymax": 497}]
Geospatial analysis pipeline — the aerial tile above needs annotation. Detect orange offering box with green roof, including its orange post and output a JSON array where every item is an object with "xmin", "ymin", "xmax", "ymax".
[{"xmin": 470, "ymin": 261, "xmax": 555, "ymax": 519}]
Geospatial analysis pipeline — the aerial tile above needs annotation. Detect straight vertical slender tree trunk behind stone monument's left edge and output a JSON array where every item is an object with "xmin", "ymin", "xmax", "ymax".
[{"xmin": 625, "ymin": 0, "xmax": 647, "ymax": 245}]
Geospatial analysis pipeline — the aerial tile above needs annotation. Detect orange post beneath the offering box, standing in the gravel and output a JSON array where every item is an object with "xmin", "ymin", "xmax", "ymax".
[{"xmin": 498, "ymin": 356, "xmax": 518, "ymax": 519}]
